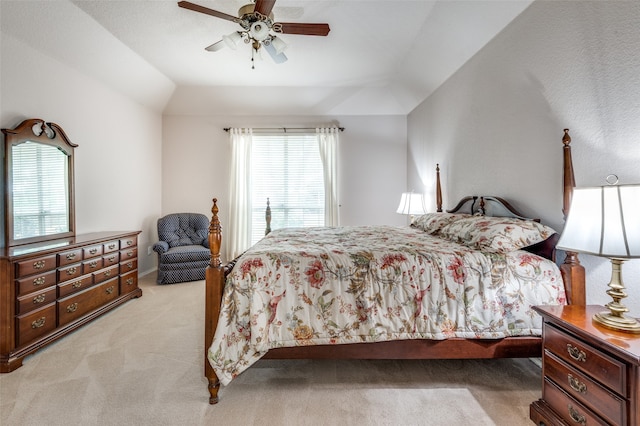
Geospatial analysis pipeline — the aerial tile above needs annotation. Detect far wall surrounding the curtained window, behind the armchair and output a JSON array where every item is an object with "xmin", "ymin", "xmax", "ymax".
[{"xmin": 162, "ymin": 113, "xmax": 407, "ymax": 262}]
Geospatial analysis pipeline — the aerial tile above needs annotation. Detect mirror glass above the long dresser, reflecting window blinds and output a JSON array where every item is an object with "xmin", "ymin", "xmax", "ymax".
[{"xmin": 11, "ymin": 141, "xmax": 69, "ymax": 240}]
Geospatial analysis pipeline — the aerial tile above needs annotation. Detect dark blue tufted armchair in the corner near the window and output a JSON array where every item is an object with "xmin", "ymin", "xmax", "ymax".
[{"xmin": 153, "ymin": 213, "xmax": 211, "ymax": 284}]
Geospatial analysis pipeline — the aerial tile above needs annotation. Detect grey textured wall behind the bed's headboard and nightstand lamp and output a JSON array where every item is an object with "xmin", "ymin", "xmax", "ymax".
[{"xmin": 408, "ymin": 0, "xmax": 640, "ymax": 306}]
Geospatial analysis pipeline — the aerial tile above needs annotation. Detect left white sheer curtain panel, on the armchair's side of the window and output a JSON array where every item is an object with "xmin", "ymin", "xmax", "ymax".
[{"xmin": 227, "ymin": 128, "xmax": 253, "ymax": 259}]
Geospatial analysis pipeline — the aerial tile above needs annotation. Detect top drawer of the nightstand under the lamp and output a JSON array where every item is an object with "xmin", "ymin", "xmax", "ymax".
[{"xmin": 544, "ymin": 323, "xmax": 627, "ymax": 397}]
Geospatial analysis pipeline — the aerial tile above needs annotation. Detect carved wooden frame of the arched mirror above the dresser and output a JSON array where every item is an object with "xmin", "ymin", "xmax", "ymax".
[{"xmin": 2, "ymin": 118, "xmax": 78, "ymax": 247}]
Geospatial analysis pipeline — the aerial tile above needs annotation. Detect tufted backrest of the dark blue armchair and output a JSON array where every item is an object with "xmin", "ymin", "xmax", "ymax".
[{"xmin": 158, "ymin": 213, "xmax": 209, "ymax": 247}]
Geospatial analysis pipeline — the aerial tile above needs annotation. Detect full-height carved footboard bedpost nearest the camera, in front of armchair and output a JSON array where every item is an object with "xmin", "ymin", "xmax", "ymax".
[{"xmin": 204, "ymin": 198, "xmax": 225, "ymax": 404}]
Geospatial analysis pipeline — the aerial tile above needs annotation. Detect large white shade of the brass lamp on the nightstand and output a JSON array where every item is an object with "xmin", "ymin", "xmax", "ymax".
[{"xmin": 557, "ymin": 185, "xmax": 640, "ymax": 259}]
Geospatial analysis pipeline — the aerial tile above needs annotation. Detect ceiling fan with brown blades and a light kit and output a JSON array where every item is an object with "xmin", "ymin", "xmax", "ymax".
[{"xmin": 178, "ymin": 0, "xmax": 330, "ymax": 68}]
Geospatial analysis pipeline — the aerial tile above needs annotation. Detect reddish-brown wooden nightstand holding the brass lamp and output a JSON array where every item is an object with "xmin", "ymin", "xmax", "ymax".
[{"xmin": 530, "ymin": 305, "xmax": 640, "ymax": 426}]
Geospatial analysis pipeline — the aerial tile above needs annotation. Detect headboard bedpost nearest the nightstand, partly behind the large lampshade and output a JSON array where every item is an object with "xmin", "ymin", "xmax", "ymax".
[{"xmin": 560, "ymin": 129, "xmax": 587, "ymax": 306}]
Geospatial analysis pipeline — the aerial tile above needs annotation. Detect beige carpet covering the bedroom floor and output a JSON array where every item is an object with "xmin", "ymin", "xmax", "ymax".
[{"xmin": 0, "ymin": 275, "xmax": 540, "ymax": 426}]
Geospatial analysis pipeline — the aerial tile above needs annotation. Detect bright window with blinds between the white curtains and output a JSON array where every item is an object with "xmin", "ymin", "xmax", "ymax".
[{"xmin": 251, "ymin": 134, "xmax": 325, "ymax": 244}]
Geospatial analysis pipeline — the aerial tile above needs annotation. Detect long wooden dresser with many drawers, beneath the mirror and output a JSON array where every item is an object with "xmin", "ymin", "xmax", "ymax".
[{"xmin": 0, "ymin": 231, "xmax": 142, "ymax": 373}]
